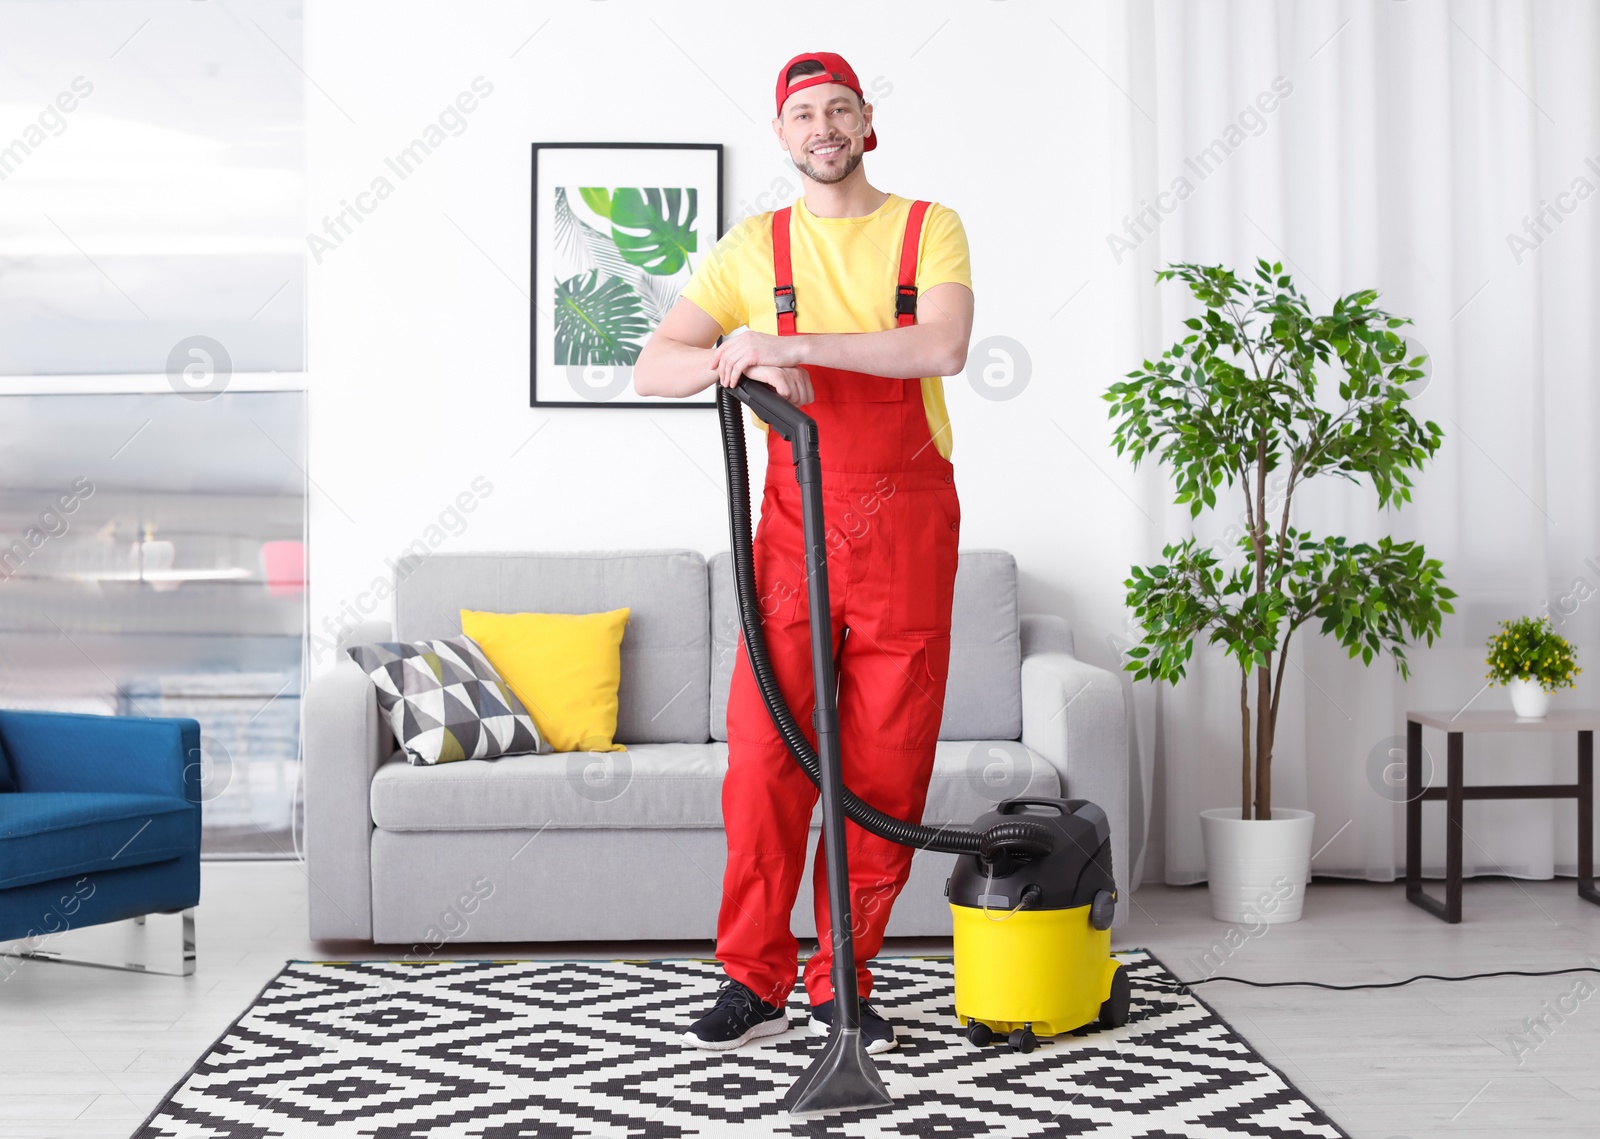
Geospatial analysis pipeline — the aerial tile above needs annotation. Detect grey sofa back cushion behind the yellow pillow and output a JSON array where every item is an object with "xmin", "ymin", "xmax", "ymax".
[{"xmin": 395, "ymin": 550, "xmax": 710, "ymax": 747}]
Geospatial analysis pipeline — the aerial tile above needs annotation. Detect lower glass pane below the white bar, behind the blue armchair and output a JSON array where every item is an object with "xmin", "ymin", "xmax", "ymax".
[{"xmin": 0, "ymin": 390, "xmax": 307, "ymax": 857}]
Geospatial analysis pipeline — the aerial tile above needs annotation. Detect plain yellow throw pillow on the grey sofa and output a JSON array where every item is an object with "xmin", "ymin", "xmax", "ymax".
[{"xmin": 461, "ymin": 609, "xmax": 629, "ymax": 752}]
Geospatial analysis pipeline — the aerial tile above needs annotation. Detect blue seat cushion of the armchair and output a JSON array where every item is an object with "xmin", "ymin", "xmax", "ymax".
[{"xmin": 0, "ymin": 790, "xmax": 200, "ymax": 889}]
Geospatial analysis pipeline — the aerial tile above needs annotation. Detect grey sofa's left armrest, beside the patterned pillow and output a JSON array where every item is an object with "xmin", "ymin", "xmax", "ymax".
[{"xmin": 304, "ymin": 641, "xmax": 394, "ymax": 939}]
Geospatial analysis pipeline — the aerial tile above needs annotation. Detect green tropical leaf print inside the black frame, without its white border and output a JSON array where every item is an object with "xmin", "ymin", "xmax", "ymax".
[{"xmin": 554, "ymin": 186, "xmax": 699, "ymax": 365}]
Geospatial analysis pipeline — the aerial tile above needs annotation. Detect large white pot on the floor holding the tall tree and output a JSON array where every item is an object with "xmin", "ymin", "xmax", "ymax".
[{"xmin": 1200, "ymin": 806, "xmax": 1317, "ymax": 925}]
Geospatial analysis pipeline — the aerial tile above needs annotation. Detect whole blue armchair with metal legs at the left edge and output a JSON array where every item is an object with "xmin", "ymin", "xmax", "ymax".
[{"xmin": 0, "ymin": 709, "xmax": 200, "ymax": 976}]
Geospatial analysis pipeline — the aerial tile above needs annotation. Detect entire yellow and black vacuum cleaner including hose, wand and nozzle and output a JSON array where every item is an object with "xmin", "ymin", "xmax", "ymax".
[{"xmin": 717, "ymin": 376, "xmax": 1128, "ymax": 1115}]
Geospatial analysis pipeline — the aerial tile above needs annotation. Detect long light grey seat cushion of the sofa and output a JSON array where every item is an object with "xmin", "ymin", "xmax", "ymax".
[{"xmin": 371, "ymin": 739, "xmax": 1061, "ymax": 830}]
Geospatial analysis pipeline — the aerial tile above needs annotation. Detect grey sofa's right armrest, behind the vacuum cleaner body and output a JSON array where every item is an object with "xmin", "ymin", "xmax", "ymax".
[{"xmin": 1022, "ymin": 646, "xmax": 1133, "ymax": 926}]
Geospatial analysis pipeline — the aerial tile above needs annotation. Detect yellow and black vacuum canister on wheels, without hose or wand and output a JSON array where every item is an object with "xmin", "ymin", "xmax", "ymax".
[{"xmin": 947, "ymin": 798, "xmax": 1128, "ymax": 1051}]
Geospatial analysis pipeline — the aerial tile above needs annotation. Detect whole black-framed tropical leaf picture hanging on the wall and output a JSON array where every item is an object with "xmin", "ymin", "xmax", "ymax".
[{"xmin": 530, "ymin": 142, "xmax": 723, "ymax": 408}]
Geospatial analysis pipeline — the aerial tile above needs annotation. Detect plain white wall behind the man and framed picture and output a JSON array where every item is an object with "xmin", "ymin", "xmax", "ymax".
[{"xmin": 302, "ymin": 0, "xmax": 1149, "ymax": 684}]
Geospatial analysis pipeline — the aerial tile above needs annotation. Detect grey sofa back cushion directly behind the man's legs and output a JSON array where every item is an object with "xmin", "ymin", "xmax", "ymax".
[{"xmin": 707, "ymin": 550, "xmax": 1022, "ymax": 741}]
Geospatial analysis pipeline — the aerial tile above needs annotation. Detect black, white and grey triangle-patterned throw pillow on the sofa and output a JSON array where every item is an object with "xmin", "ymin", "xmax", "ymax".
[{"xmin": 346, "ymin": 637, "xmax": 554, "ymax": 766}]
